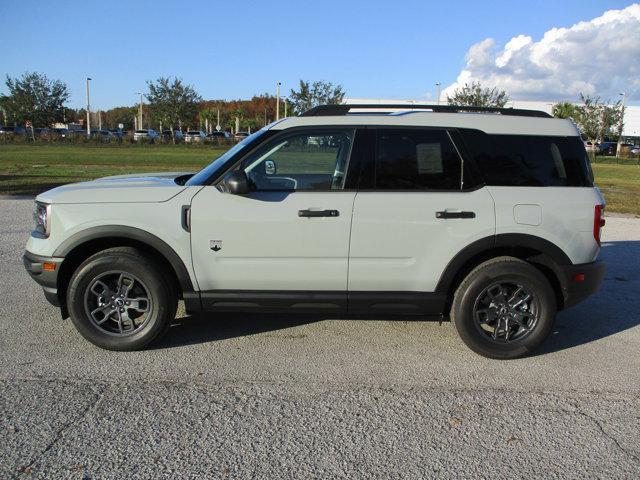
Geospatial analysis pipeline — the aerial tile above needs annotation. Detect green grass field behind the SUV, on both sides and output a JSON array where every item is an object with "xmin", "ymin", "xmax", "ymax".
[{"xmin": 0, "ymin": 144, "xmax": 640, "ymax": 215}]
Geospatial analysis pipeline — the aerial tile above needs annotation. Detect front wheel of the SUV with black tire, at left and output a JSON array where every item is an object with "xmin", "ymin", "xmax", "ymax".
[{"xmin": 67, "ymin": 247, "xmax": 178, "ymax": 350}]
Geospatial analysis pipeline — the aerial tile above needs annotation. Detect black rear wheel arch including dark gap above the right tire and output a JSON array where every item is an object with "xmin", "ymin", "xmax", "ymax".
[{"xmin": 436, "ymin": 233, "xmax": 573, "ymax": 312}]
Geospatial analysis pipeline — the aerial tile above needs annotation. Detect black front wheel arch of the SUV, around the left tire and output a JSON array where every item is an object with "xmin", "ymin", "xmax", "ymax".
[{"xmin": 53, "ymin": 225, "xmax": 194, "ymax": 318}]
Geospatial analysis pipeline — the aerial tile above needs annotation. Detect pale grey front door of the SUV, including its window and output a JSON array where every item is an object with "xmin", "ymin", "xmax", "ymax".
[{"xmin": 191, "ymin": 129, "xmax": 355, "ymax": 308}]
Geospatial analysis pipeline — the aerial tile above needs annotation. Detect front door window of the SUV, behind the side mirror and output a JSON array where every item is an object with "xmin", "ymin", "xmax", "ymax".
[{"xmin": 241, "ymin": 130, "xmax": 354, "ymax": 191}]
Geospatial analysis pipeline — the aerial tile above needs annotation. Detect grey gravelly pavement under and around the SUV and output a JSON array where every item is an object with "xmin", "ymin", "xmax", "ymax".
[{"xmin": 0, "ymin": 199, "xmax": 640, "ymax": 479}]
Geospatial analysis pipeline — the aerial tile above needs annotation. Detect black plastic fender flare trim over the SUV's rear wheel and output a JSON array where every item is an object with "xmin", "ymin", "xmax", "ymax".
[{"xmin": 436, "ymin": 233, "xmax": 573, "ymax": 295}]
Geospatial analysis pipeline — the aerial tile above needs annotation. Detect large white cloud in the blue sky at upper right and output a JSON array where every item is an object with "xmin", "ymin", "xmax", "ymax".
[{"xmin": 443, "ymin": 3, "xmax": 640, "ymax": 101}]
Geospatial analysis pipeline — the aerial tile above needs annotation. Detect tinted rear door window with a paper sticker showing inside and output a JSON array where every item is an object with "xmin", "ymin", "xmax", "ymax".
[{"xmin": 376, "ymin": 129, "xmax": 461, "ymax": 190}]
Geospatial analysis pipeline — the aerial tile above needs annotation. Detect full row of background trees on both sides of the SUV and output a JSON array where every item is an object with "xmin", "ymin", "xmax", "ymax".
[{"xmin": 0, "ymin": 72, "xmax": 624, "ymax": 143}]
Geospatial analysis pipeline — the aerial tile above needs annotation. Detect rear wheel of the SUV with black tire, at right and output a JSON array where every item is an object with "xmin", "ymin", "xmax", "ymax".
[{"xmin": 451, "ymin": 257, "xmax": 557, "ymax": 359}]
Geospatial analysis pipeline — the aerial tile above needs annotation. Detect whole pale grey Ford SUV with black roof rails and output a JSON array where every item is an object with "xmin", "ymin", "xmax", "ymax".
[{"xmin": 24, "ymin": 105, "xmax": 604, "ymax": 358}]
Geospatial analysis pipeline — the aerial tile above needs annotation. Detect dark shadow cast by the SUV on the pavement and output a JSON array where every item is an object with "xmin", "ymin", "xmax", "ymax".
[{"xmin": 152, "ymin": 241, "xmax": 640, "ymax": 356}]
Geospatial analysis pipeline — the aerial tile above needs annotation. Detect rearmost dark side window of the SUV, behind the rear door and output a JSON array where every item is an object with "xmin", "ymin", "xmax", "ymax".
[{"xmin": 461, "ymin": 130, "xmax": 593, "ymax": 187}]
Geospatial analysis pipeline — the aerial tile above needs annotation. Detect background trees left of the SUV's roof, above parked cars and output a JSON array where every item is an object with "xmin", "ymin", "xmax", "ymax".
[{"xmin": 0, "ymin": 72, "xmax": 345, "ymax": 131}]
